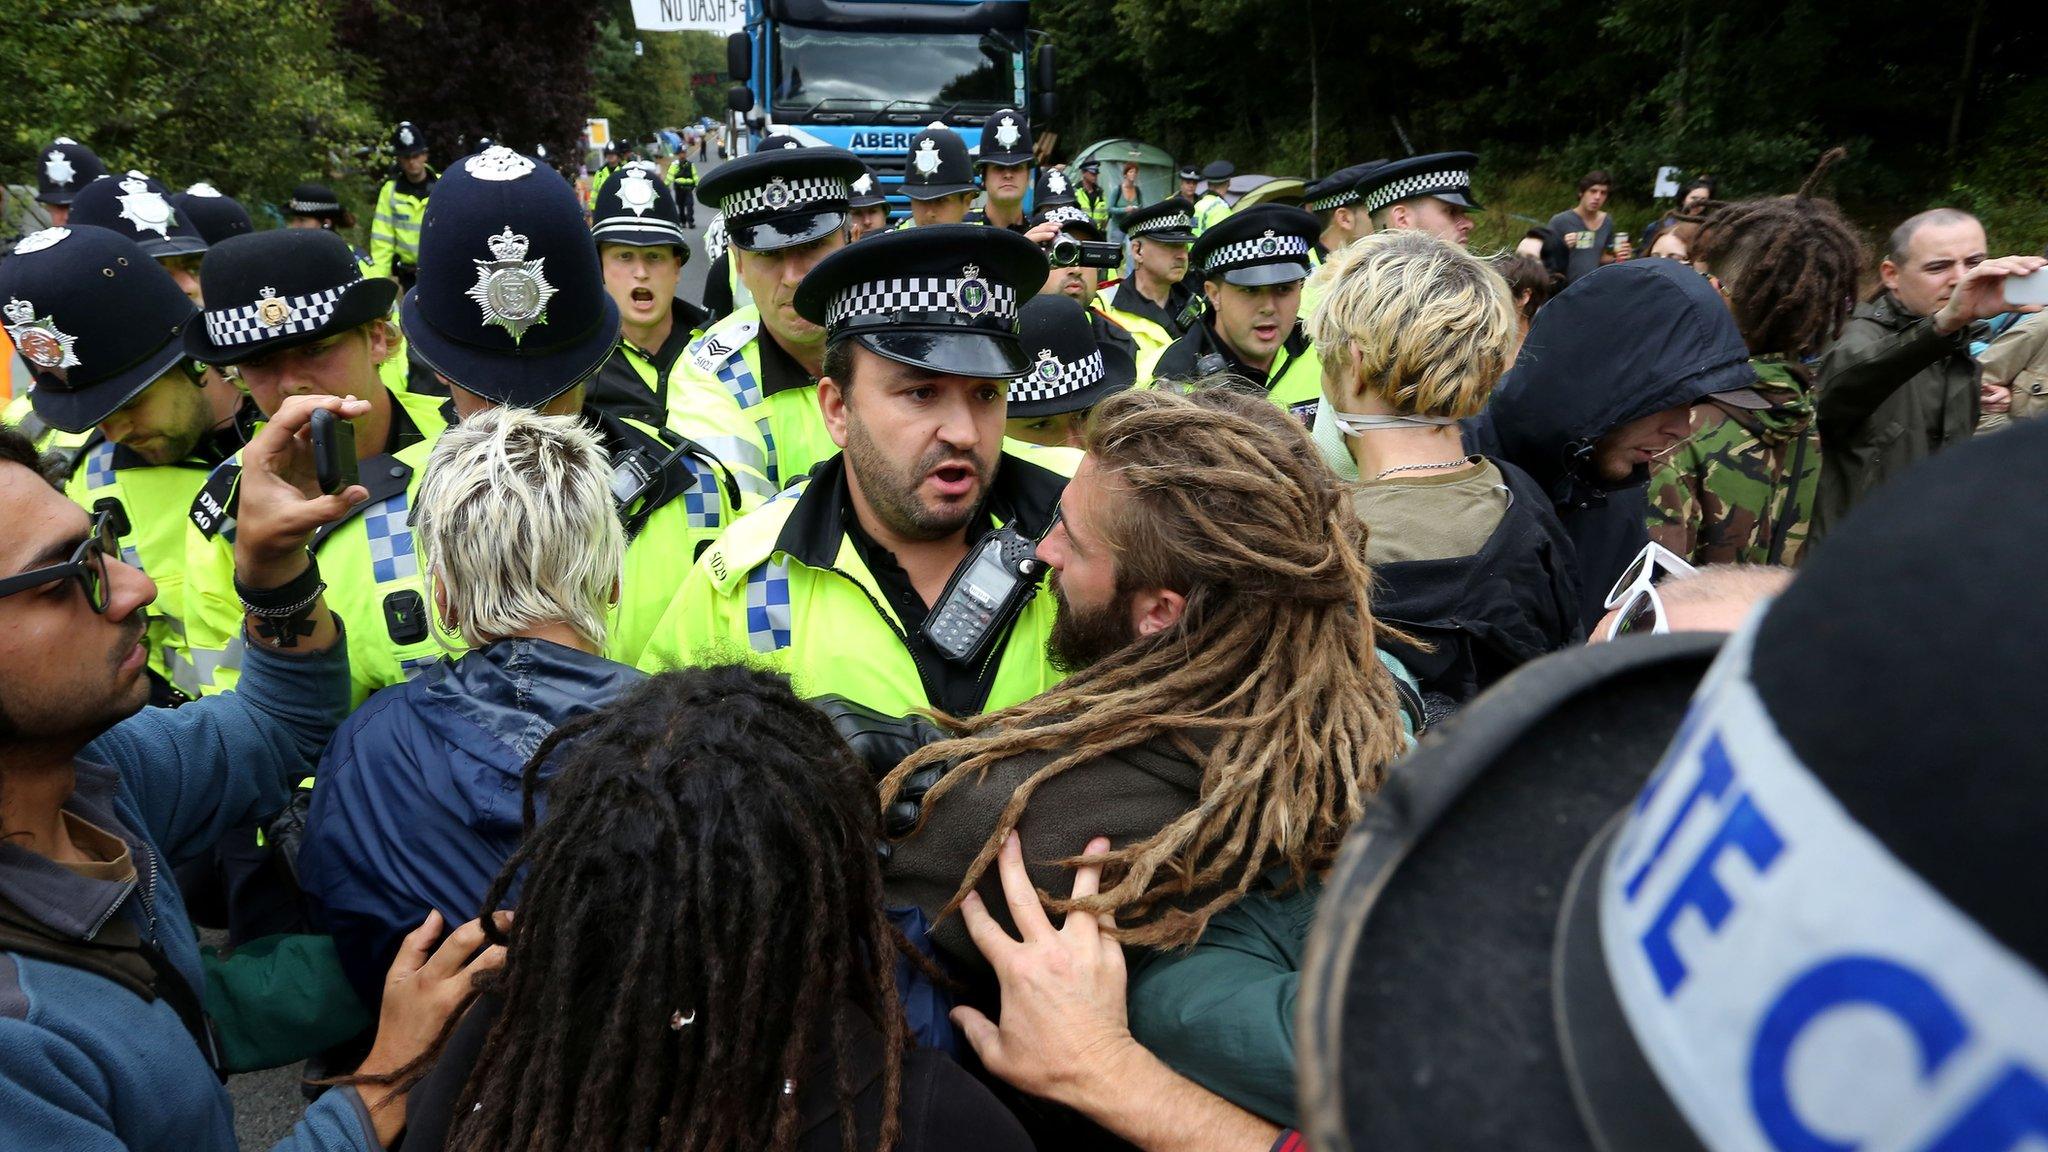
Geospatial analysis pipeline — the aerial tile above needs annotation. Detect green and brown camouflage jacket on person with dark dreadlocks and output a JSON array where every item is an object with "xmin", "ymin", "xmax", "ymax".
[{"xmin": 1649, "ymin": 357, "xmax": 1821, "ymax": 564}]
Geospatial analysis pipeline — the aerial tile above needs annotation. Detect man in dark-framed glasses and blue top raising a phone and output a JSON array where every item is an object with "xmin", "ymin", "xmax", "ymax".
[{"xmin": 0, "ymin": 396, "xmax": 502, "ymax": 1150}]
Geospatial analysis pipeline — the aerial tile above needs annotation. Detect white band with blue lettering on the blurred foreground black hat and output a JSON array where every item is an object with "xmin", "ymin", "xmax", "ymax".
[{"xmin": 1599, "ymin": 613, "xmax": 2048, "ymax": 1152}]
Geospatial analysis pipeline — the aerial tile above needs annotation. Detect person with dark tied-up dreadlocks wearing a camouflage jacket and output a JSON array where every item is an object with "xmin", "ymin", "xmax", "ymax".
[{"xmin": 1649, "ymin": 148, "xmax": 1864, "ymax": 564}]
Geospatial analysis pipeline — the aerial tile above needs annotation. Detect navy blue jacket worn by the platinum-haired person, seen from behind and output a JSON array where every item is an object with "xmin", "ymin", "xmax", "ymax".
[{"xmin": 299, "ymin": 640, "xmax": 641, "ymax": 1009}]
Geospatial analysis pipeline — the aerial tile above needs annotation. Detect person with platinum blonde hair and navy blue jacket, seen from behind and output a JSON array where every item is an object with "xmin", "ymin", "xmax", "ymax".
[{"xmin": 299, "ymin": 408, "xmax": 641, "ymax": 1009}]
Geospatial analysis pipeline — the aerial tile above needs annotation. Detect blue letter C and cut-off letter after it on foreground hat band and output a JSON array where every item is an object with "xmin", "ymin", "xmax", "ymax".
[{"xmin": 1749, "ymin": 955, "xmax": 2048, "ymax": 1152}]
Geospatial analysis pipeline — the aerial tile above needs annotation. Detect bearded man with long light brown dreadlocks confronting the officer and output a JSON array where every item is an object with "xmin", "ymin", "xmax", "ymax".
[{"xmin": 883, "ymin": 387, "xmax": 1413, "ymax": 1123}]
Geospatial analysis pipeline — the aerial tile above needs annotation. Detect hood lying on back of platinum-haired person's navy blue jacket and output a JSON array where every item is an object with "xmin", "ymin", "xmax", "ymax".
[{"xmin": 418, "ymin": 637, "xmax": 645, "ymax": 832}]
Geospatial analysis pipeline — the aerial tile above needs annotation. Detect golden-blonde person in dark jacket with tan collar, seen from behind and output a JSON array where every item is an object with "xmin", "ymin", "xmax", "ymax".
[{"xmin": 1309, "ymin": 230, "xmax": 1581, "ymax": 713}]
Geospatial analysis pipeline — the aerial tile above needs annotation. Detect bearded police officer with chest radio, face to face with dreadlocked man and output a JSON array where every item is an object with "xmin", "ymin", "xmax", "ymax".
[{"xmin": 641, "ymin": 225, "xmax": 1077, "ymax": 715}]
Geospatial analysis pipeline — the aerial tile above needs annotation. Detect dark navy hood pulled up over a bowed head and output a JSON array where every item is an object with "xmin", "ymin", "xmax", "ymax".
[{"xmin": 1466, "ymin": 260, "xmax": 1755, "ymax": 504}]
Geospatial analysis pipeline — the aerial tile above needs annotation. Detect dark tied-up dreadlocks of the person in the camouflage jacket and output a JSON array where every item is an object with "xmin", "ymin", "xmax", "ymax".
[{"xmin": 1692, "ymin": 148, "xmax": 1864, "ymax": 357}]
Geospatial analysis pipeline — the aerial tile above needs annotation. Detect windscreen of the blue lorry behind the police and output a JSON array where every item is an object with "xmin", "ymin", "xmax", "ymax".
[{"xmin": 774, "ymin": 25, "xmax": 1016, "ymax": 119}]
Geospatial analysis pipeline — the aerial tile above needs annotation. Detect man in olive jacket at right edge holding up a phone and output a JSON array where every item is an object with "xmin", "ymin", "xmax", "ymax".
[{"xmin": 1808, "ymin": 207, "xmax": 2048, "ymax": 541}]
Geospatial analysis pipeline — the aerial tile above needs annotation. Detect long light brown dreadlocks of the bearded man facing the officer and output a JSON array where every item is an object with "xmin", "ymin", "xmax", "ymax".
[{"xmin": 883, "ymin": 387, "xmax": 1405, "ymax": 947}]
